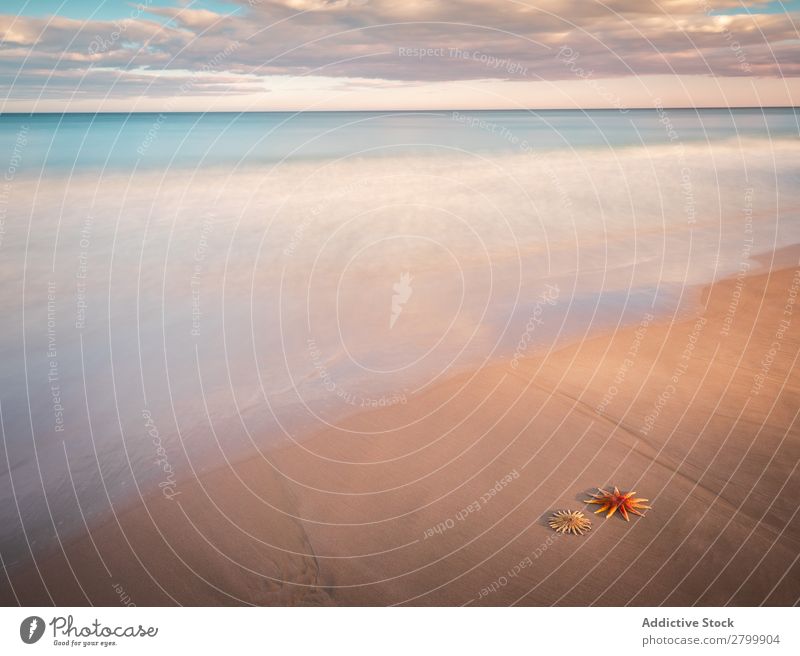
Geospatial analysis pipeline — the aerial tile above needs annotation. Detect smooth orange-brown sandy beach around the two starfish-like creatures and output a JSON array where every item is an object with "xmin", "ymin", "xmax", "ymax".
[{"xmin": 0, "ymin": 249, "xmax": 800, "ymax": 606}]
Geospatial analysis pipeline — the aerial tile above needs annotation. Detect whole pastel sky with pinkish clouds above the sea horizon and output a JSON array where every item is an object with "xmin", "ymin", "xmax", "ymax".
[{"xmin": 0, "ymin": 0, "xmax": 800, "ymax": 112}]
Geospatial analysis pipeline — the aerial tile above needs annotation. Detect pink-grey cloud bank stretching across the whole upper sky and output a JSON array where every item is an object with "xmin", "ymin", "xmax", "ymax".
[{"xmin": 0, "ymin": 0, "xmax": 800, "ymax": 109}]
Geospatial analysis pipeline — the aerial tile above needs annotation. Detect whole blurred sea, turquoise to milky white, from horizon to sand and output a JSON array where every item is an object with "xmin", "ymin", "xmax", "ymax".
[{"xmin": 0, "ymin": 109, "xmax": 800, "ymax": 566}]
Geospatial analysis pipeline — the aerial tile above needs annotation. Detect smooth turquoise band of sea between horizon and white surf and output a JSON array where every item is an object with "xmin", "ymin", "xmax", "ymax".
[{"xmin": 0, "ymin": 109, "xmax": 800, "ymax": 173}]
